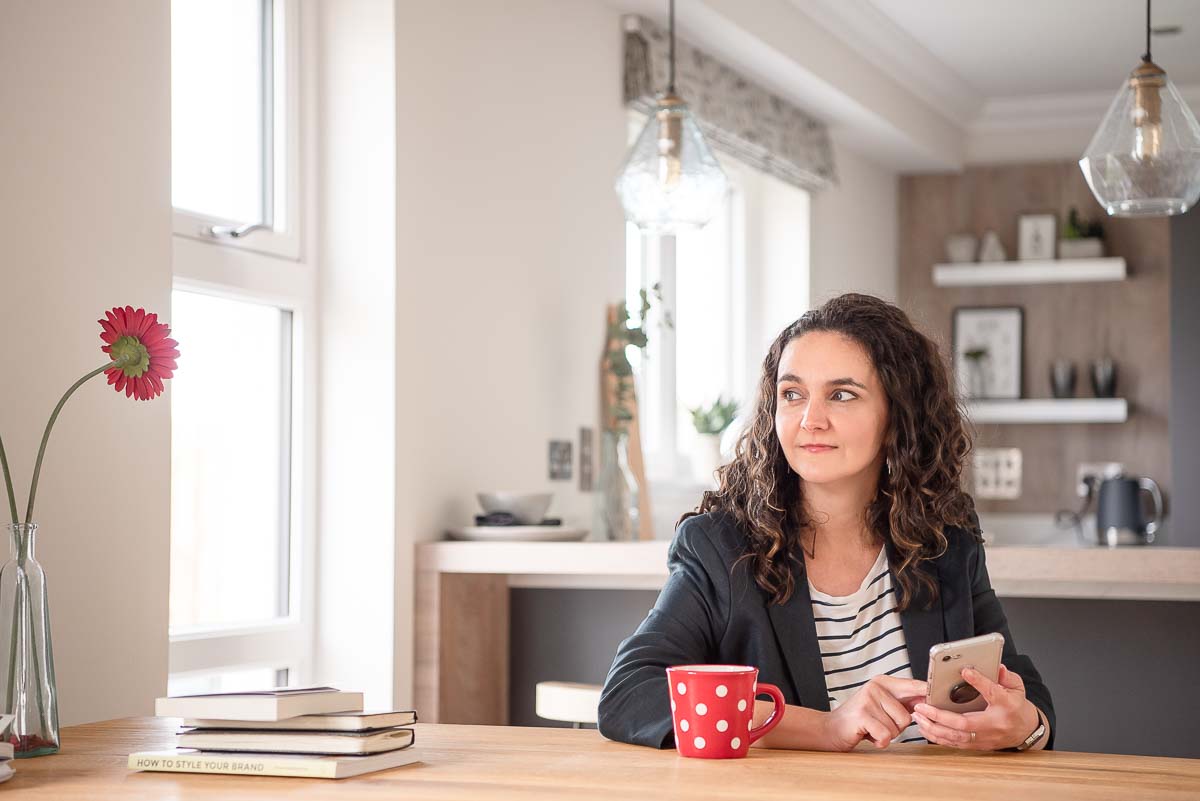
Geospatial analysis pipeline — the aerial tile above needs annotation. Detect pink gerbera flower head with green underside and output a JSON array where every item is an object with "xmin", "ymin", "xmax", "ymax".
[{"xmin": 97, "ymin": 306, "xmax": 179, "ymax": 401}]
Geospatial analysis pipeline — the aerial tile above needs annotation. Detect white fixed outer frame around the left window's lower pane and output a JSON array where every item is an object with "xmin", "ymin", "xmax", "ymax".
[{"xmin": 168, "ymin": 0, "xmax": 319, "ymax": 685}]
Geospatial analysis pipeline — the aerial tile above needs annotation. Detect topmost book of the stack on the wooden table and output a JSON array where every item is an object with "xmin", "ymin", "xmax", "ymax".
[{"xmin": 155, "ymin": 687, "xmax": 362, "ymax": 721}]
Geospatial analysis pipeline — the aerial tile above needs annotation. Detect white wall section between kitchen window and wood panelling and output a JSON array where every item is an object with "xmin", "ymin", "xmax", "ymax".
[{"xmin": 809, "ymin": 136, "xmax": 899, "ymax": 307}]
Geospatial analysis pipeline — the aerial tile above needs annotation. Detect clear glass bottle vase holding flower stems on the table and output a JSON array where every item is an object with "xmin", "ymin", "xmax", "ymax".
[{"xmin": 0, "ymin": 523, "xmax": 59, "ymax": 758}]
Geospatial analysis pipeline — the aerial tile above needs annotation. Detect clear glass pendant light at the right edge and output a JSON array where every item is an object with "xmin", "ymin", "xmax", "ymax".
[{"xmin": 1079, "ymin": 0, "xmax": 1200, "ymax": 217}]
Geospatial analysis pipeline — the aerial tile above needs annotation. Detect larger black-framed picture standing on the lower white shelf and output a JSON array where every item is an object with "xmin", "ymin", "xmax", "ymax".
[{"xmin": 953, "ymin": 306, "xmax": 1025, "ymax": 399}]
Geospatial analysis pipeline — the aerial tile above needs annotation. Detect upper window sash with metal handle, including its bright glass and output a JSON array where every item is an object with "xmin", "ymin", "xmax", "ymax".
[{"xmin": 172, "ymin": 0, "xmax": 299, "ymax": 258}]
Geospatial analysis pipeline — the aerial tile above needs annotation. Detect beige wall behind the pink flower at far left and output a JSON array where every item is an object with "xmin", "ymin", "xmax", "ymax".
[{"xmin": 0, "ymin": 0, "xmax": 172, "ymax": 724}]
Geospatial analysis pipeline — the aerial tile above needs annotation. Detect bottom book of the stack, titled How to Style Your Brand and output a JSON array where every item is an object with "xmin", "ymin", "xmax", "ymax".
[{"xmin": 128, "ymin": 748, "xmax": 420, "ymax": 778}]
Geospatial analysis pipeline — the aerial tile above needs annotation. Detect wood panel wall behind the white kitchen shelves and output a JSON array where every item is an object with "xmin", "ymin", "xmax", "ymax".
[{"xmin": 899, "ymin": 162, "xmax": 1171, "ymax": 513}]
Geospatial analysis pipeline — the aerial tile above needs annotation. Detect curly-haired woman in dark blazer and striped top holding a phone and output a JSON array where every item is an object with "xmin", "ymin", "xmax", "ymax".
[{"xmin": 599, "ymin": 294, "xmax": 1055, "ymax": 751}]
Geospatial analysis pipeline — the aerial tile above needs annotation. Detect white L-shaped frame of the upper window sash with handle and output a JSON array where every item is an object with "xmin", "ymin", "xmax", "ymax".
[{"xmin": 173, "ymin": 0, "xmax": 302, "ymax": 260}]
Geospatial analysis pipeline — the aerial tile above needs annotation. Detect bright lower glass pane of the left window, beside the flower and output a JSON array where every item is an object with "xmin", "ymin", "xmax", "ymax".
[{"xmin": 170, "ymin": 290, "xmax": 292, "ymax": 633}]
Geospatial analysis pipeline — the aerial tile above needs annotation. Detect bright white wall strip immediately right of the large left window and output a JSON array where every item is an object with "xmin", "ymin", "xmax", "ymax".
[{"xmin": 311, "ymin": 0, "xmax": 398, "ymax": 709}]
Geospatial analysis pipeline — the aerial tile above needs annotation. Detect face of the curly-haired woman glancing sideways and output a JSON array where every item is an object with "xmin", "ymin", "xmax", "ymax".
[{"xmin": 775, "ymin": 331, "xmax": 888, "ymax": 484}]
